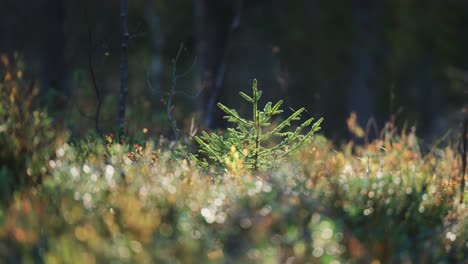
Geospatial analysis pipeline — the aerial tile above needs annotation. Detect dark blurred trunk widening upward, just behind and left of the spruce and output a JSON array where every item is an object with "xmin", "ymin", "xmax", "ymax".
[{"xmin": 194, "ymin": 0, "xmax": 240, "ymax": 128}]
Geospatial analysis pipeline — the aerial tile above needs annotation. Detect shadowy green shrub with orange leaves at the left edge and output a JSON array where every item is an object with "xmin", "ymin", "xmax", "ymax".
[{"xmin": 0, "ymin": 55, "xmax": 66, "ymax": 200}]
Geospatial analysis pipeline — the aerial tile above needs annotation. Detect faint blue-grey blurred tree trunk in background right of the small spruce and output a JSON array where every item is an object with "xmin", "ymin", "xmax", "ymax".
[{"xmin": 347, "ymin": 0, "xmax": 379, "ymax": 132}]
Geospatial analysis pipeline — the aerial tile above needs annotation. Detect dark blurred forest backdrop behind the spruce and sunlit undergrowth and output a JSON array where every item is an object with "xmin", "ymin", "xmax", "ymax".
[{"xmin": 0, "ymin": 0, "xmax": 468, "ymax": 139}]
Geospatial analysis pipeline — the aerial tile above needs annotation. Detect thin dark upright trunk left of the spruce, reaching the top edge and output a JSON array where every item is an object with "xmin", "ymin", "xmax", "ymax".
[{"xmin": 118, "ymin": 0, "xmax": 129, "ymax": 138}]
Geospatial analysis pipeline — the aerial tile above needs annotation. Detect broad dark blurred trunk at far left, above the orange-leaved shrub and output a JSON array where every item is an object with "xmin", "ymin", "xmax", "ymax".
[{"xmin": 41, "ymin": 0, "xmax": 69, "ymax": 111}]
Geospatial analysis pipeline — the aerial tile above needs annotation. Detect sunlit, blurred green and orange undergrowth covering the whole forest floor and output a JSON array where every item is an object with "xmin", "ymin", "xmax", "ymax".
[{"xmin": 0, "ymin": 60, "xmax": 468, "ymax": 263}]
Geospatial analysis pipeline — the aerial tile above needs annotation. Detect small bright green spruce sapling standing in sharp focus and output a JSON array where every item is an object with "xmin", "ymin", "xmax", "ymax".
[{"xmin": 195, "ymin": 80, "xmax": 323, "ymax": 170}]
